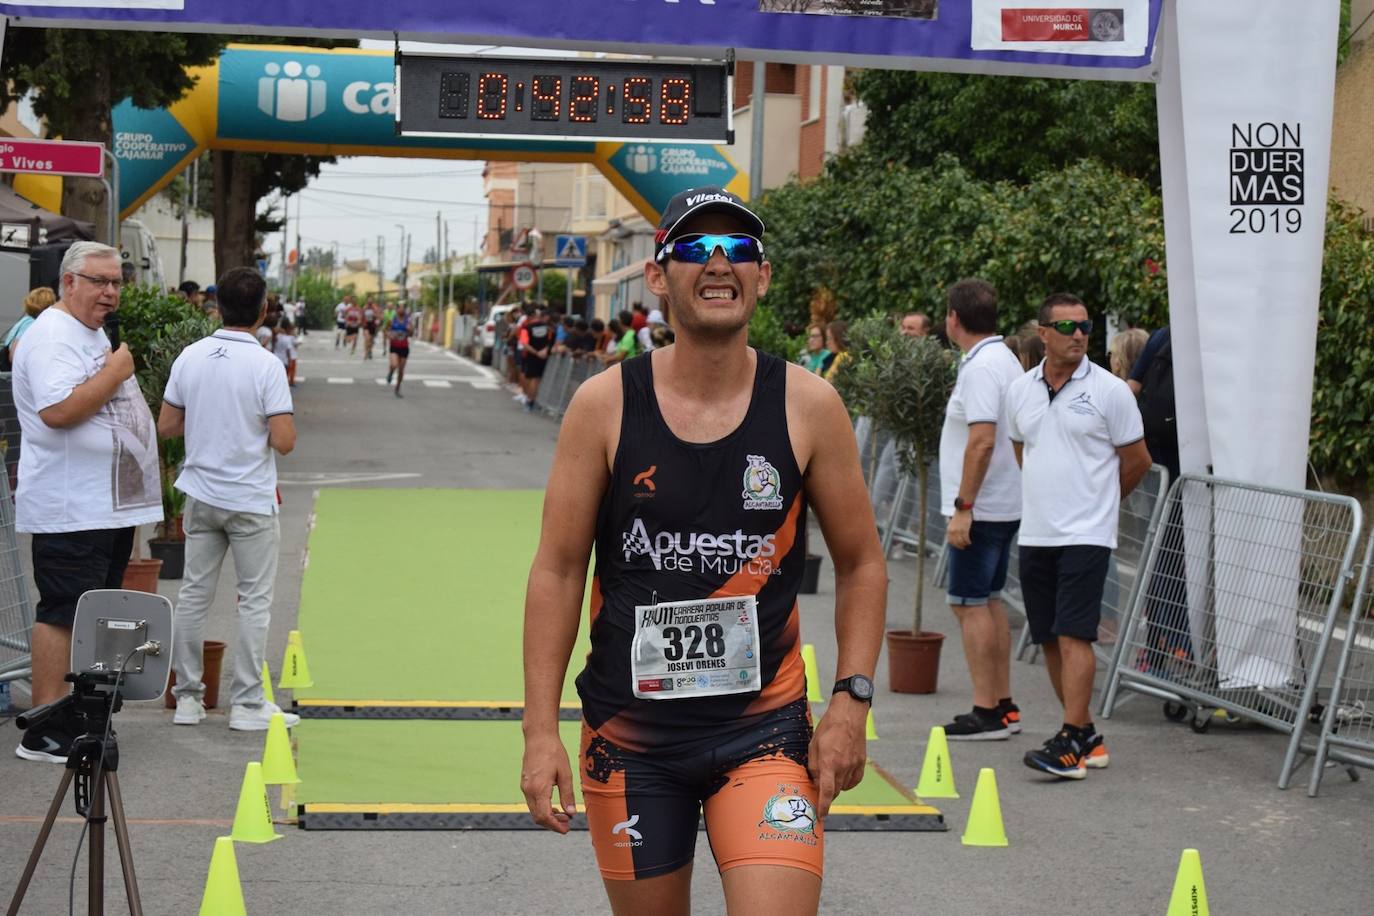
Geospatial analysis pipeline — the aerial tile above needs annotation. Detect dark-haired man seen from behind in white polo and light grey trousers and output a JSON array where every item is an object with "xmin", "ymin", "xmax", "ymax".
[{"xmin": 158, "ymin": 268, "xmax": 300, "ymax": 731}]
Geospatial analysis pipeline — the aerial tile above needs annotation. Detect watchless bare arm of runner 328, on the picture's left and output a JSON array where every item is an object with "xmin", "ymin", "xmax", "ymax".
[{"xmin": 521, "ymin": 375, "xmax": 620, "ymax": 834}]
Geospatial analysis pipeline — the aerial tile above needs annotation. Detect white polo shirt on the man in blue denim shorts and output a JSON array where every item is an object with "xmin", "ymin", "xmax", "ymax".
[{"xmin": 940, "ymin": 335, "xmax": 1024, "ymax": 522}]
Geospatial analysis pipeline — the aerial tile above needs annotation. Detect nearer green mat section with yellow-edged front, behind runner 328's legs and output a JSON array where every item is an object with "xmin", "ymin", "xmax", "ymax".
[{"xmin": 294, "ymin": 720, "xmax": 944, "ymax": 829}]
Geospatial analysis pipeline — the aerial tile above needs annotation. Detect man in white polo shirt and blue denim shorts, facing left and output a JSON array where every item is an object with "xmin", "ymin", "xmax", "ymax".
[{"xmin": 940, "ymin": 280, "xmax": 1022, "ymax": 742}]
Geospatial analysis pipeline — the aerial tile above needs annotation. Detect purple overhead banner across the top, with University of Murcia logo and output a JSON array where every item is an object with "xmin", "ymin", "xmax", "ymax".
[{"xmin": 0, "ymin": 0, "xmax": 1161, "ymax": 78}]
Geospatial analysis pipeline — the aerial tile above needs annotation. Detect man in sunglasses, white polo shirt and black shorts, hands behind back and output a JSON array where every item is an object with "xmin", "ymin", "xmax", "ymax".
[{"xmin": 1007, "ymin": 293, "xmax": 1150, "ymax": 779}]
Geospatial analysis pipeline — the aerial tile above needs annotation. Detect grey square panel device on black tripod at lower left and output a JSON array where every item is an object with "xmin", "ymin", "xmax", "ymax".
[{"xmin": 8, "ymin": 589, "xmax": 172, "ymax": 916}]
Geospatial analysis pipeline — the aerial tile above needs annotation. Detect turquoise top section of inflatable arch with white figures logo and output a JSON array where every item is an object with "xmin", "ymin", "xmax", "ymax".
[{"xmin": 217, "ymin": 47, "xmax": 595, "ymax": 154}]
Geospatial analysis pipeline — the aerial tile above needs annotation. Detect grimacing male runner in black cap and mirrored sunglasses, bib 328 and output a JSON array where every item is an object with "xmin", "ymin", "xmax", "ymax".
[{"xmin": 521, "ymin": 188, "xmax": 888, "ymax": 916}]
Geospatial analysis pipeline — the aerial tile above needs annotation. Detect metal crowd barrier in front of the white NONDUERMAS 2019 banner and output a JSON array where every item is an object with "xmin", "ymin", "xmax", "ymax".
[{"xmin": 1102, "ymin": 474, "xmax": 1363, "ymax": 788}]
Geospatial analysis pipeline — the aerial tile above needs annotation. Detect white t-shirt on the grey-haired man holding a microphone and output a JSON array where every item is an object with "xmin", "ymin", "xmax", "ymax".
[{"xmin": 14, "ymin": 308, "xmax": 162, "ymax": 534}]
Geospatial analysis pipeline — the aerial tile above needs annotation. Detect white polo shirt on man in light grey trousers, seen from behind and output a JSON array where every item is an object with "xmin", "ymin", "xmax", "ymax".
[{"xmin": 164, "ymin": 328, "xmax": 293, "ymax": 515}]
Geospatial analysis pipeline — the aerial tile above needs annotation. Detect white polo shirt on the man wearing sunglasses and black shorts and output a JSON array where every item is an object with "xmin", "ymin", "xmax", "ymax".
[{"xmin": 1006, "ymin": 357, "xmax": 1145, "ymax": 549}]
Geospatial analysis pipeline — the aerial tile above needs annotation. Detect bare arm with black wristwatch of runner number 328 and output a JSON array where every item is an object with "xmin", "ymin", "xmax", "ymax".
[{"xmin": 787, "ymin": 367, "xmax": 888, "ymax": 817}]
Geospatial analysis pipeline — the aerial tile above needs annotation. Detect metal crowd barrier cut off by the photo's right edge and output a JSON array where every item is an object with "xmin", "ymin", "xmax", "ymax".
[{"xmin": 1301, "ymin": 537, "xmax": 1374, "ymax": 798}]
